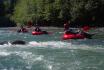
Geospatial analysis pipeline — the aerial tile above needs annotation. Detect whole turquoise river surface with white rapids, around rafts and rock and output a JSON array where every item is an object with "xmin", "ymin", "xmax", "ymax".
[{"xmin": 0, "ymin": 28, "xmax": 104, "ymax": 70}]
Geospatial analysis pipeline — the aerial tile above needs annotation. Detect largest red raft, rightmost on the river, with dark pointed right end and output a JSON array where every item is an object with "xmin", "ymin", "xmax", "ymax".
[{"xmin": 62, "ymin": 29, "xmax": 94, "ymax": 40}]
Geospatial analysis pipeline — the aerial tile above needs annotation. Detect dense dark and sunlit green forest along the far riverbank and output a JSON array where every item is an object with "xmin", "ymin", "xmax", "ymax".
[{"xmin": 0, "ymin": 0, "xmax": 104, "ymax": 27}]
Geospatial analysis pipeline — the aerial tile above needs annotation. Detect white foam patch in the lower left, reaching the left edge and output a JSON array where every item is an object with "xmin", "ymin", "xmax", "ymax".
[{"xmin": 0, "ymin": 51, "xmax": 44, "ymax": 69}]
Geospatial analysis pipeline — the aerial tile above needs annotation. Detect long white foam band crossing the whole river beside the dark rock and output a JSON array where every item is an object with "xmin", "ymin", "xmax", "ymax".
[{"xmin": 0, "ymin": 41, "xmax": 104, "ymax": 51}]
